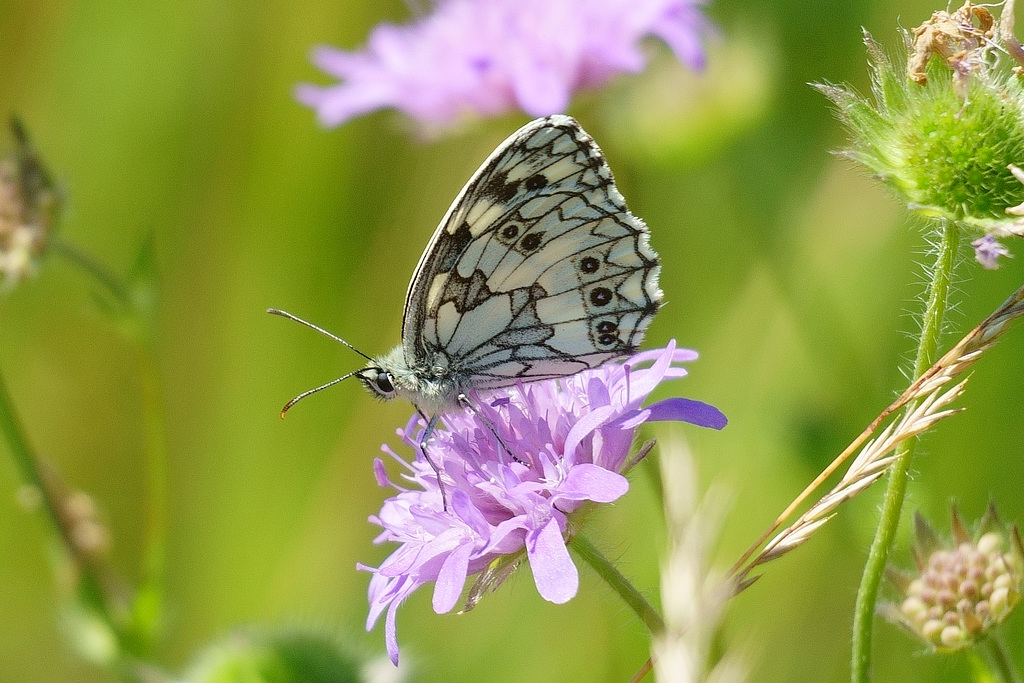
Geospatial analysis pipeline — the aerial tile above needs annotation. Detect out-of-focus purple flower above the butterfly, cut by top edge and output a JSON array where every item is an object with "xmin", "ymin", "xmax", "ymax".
[{"xmin": 296, "ymin": 0, "xmax": 709, "ymax": 127}]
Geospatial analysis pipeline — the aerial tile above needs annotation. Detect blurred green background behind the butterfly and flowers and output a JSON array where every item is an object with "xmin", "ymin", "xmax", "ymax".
[{"xmin": 0, "ymin": 0, "xmax": 1024, "ymax": 682}]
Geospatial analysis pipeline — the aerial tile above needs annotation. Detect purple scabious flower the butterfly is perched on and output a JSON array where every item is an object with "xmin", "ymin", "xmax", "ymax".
[{"xmin": 358, "ymin": 341, "xmax": 726, "ymax": 664}]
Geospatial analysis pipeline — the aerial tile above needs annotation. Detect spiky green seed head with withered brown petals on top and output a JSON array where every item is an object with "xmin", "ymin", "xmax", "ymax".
[{"xmin": 817, "ymin": 0, "xmax": 1024, "ymax": 267}]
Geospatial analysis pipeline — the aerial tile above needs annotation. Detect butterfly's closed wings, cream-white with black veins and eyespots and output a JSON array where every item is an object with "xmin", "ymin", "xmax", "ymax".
[{"xmin": 402, "ymin": 116, "xmax": 662, "ymax": 388}]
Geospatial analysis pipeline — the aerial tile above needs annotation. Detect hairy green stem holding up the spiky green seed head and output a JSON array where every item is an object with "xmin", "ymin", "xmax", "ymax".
[{"xmin": 850, "ymin": 221, "xmax": 959, "ymax": 683}]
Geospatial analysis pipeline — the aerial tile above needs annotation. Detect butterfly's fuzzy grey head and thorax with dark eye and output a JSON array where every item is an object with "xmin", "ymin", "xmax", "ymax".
[{"xmin": 357, "ymin": 345, "xmax": 466, "ymax": 415}]
